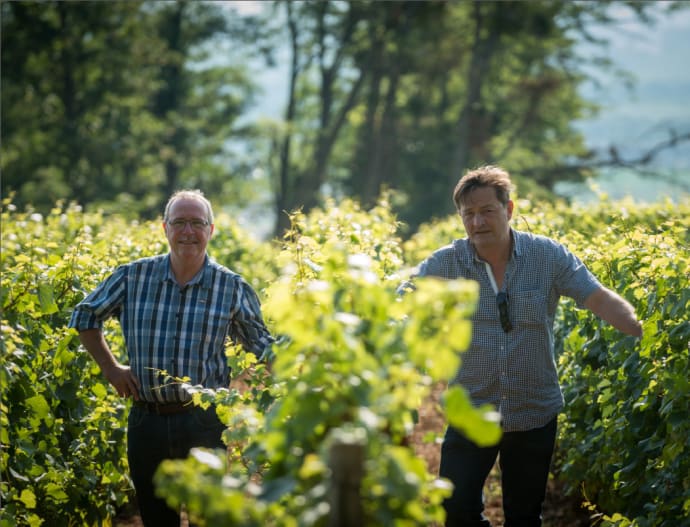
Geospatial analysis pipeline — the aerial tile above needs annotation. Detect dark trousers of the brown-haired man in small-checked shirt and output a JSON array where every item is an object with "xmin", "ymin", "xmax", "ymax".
[{"xmin": 439, "ymin": 417, "xmax": 557, "ymax": 527}]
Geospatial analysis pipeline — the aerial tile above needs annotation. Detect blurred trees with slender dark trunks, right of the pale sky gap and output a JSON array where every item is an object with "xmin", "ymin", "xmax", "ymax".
[{"xmin": 255, "ymin": 1, "xmax": 683, "ymax": 233}]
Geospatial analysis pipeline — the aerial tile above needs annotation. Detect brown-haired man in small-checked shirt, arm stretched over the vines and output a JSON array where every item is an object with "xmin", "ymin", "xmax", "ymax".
[{"xmin": 402, "ymin": 166, "xmax": 642, "ymax": 527}]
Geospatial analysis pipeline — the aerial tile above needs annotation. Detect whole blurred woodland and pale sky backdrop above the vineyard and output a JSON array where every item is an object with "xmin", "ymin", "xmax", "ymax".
[{"xmin": 0, "ymin": 1, "xmax": 690, "ymax": 235}]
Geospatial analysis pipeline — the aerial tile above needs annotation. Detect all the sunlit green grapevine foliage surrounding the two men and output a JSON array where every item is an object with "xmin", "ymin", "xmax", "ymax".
[{"xmin": 0, "ymin": 197, "xmax": 690, "ymax": 527}]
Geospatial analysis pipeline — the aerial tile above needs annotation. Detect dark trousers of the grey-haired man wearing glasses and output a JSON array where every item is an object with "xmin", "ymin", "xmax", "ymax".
[{"xmin": 127, "ymin": 406, "xmax": 226, "ymax": 527}]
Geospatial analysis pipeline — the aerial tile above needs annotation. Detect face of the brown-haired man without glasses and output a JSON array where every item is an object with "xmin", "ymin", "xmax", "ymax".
[{"xmin": 460, "ymin": 187, "xmax": 513, "ymax": 249}]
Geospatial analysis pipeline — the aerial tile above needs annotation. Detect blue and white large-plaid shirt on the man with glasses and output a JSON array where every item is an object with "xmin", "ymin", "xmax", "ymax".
[{"xmin": 69, "ymin": 255, "xmax": 273, "ymax": 403}]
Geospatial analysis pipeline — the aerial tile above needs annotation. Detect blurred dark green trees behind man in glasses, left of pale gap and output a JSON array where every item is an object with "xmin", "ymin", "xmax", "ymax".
[{"xmin": 0, "ymin": 1, "xmax": 253, "ymax": 217}]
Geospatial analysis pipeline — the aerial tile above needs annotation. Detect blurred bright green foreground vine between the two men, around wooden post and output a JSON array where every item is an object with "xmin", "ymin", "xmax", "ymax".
[{"xmin": 153, "ymin": 198, "xmax": 498, "ymax": 526}]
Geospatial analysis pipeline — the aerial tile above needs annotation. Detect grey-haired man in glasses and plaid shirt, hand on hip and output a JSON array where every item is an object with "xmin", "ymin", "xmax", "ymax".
[{"xmin": 70, "ymin": 190, "xmax": 273, "ymax": 527}]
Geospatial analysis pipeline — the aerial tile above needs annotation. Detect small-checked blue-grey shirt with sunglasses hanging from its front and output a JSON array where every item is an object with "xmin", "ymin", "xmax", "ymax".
[{"xmin": 408, "ymin": 230, "xmax": 601, "ymax": 432}]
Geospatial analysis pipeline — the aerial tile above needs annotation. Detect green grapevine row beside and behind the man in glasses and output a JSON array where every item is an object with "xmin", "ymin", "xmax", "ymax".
[{"xmin": 0, "ymin": 199, "xmax": 271, "ymax": 526}]
